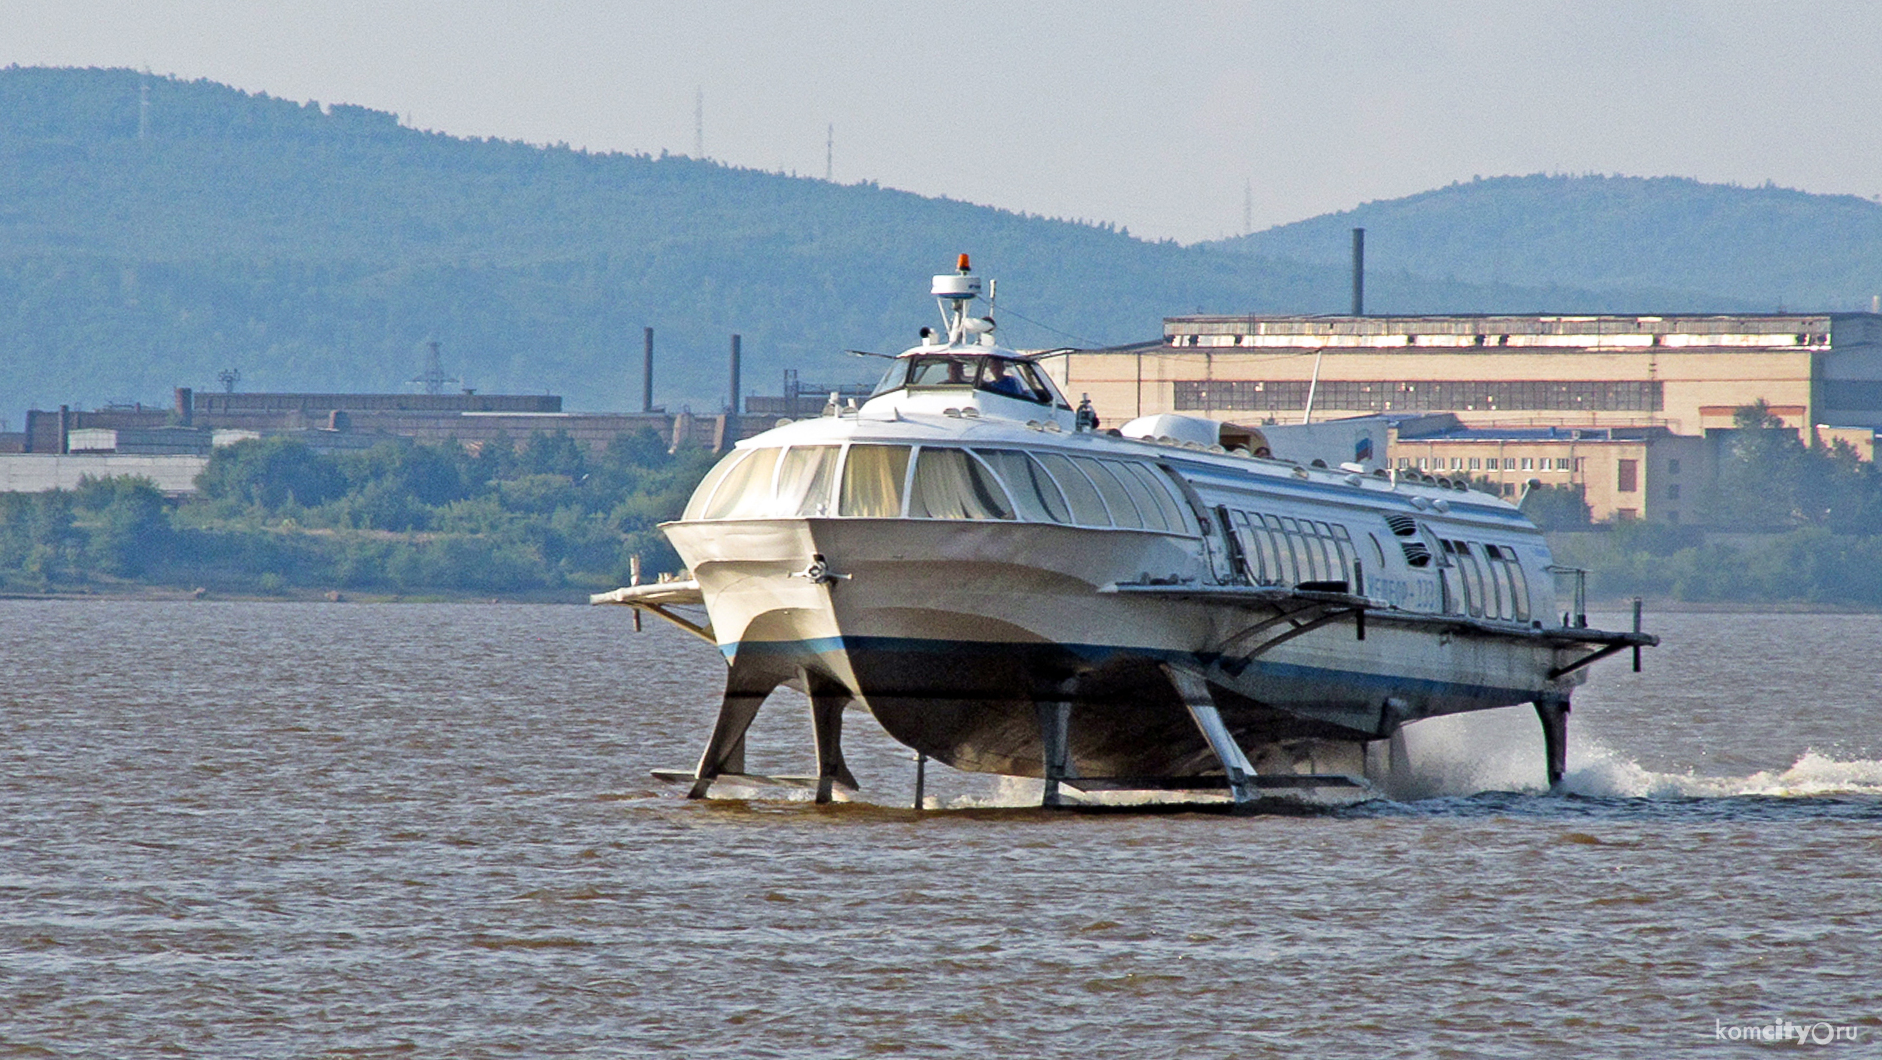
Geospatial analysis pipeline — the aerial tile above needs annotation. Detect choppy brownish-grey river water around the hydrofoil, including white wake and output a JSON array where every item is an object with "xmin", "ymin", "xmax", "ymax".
[{"xmin": 0, "ymin": 602, "xmax": 1882, "ymax": 1058}]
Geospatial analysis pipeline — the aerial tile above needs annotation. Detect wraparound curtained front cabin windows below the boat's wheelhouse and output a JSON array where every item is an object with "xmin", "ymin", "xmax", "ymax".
[{"xmin": 683, "ymin": 444, "xmax": 1199, "ymax": 537}]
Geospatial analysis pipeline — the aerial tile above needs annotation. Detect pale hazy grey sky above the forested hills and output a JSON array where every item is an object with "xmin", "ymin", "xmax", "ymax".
[{"xmin": 14, "ymin": 0, "xmax": 1882, "ymax": 241}]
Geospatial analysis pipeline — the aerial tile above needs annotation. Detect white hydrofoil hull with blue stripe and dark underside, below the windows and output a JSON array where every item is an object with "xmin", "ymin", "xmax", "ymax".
[{"xmin": 666, "ymin": 518, "xmax": 1581, "ymax": 778}]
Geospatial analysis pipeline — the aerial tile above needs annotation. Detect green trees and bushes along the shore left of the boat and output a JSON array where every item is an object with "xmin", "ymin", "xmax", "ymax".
[{"xmin": 0, "ymin": 431, "xmax": 713, "ymax": 593}]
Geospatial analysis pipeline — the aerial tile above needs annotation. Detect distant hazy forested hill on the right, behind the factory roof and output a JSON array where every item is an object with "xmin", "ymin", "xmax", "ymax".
[{"xmin": 1218, "ymin": 175, "xmax": 1882, "ymax": 311}]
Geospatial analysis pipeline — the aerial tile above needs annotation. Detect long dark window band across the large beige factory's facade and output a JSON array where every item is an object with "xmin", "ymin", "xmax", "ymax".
[{"xmin": 1174, "ymin": 378, "xmax": 1666, "ymax": 412}]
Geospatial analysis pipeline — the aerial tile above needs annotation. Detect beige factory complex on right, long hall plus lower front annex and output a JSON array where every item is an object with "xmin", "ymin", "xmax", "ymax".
[{"xmin": 1054, "ymin": 313, "xmax": 1882, "ymax": 523}]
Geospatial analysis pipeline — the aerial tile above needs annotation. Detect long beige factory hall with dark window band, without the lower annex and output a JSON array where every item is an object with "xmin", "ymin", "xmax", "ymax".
[{"xmin": 1056, "ymin": 313, "xmax": 1882, "ymax": 435}]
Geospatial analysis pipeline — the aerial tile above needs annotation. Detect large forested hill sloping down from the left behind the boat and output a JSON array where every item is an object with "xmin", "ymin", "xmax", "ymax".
[{"xmin": 0, "ymin": 68, "xmax": 1720, "ymax": 421}]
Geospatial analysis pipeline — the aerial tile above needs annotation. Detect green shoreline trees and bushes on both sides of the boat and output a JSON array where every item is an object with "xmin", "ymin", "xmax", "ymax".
[{"xmin": 0, "ymin": 405, "xmax": 1882, "ymax": 610}]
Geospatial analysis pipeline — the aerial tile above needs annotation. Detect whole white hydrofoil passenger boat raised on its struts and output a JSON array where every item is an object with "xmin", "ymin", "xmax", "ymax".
[{"xmin": 593, "ymin": 254, "xmax": 1658, "ymax": 806}]
